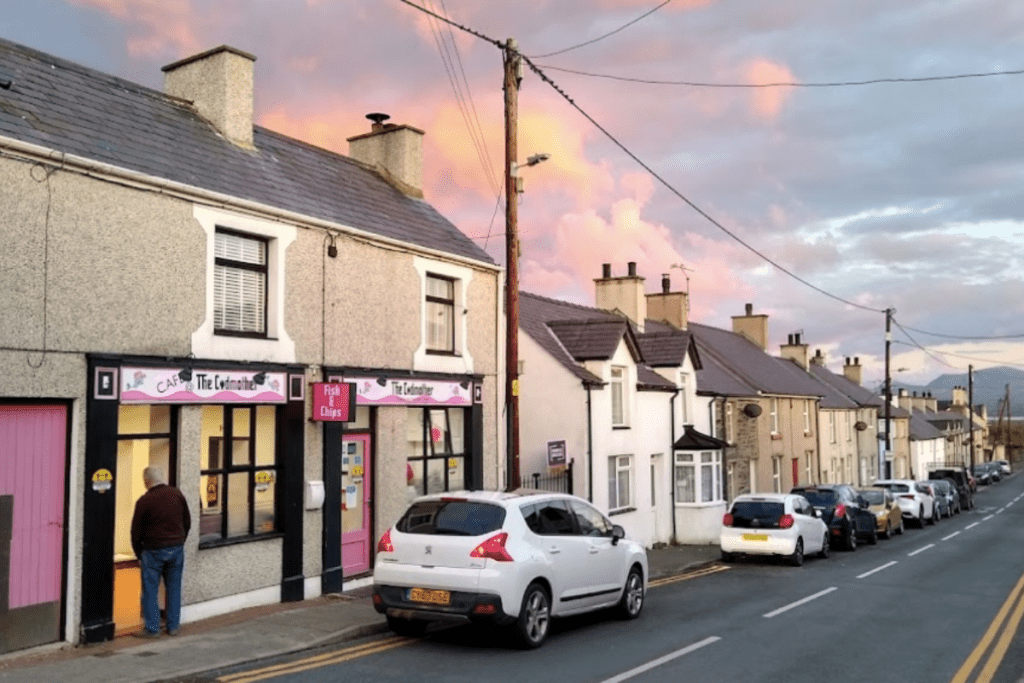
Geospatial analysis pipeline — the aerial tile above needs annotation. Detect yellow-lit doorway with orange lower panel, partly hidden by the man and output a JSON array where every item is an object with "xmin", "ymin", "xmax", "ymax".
[{"xmin": 114, "ymin": 405, "xmax": 177, "ymax": 636}]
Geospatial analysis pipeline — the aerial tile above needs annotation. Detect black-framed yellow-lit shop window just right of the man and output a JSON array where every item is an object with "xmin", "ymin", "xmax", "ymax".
[{"xmin": 200, "ymin": 405, "xmax": 279, "ymax": 545}]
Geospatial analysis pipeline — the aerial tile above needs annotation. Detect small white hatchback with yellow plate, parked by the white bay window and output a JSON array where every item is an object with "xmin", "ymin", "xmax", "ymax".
[{"xmin": 719, "ymin": 494, "xmax": 829, "ymax": 566}]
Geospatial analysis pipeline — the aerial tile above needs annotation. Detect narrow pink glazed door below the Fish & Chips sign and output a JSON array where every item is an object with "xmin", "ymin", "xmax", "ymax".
[{"xmin": 341, "ymin": 434, "xmax": 373, "ymax": 577}]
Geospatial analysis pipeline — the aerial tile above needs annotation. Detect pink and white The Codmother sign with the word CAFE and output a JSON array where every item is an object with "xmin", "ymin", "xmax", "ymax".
[{"xmin": 121, "ymin": 368, "xmax": 288, "ymax": 403}]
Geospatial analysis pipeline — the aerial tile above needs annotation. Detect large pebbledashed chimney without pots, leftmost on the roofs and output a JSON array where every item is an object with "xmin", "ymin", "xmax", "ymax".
[{"xmin": 162, "ymin": 45, "xmax": 256, "ymax": 148}]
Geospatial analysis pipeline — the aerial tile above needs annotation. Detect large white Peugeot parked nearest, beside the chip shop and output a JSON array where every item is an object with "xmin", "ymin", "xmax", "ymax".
[{"xmin": 373, "ymin": 490, "xmax": 648, "ymax": 648}]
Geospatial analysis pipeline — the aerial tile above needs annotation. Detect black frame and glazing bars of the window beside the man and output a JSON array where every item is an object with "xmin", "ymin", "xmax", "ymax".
[{"xmin": 198, "ymin": 403, "xmax": 284, "ymax": 550}]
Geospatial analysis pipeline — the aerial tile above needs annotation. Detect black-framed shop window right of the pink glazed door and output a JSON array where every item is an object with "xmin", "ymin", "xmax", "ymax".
[{"xmin": 407, "ymin": 408, "xmax": 466, "ymax": 496}]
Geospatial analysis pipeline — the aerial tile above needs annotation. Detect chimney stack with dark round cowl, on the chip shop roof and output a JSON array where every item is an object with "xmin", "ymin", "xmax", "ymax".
[{"xmin": 348, "ymin": 113, "xmax": 424, "ymax": 199}]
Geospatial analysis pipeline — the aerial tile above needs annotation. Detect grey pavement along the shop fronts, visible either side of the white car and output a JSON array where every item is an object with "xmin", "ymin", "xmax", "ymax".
[{"xmin": 0, "ymin": 545, "xmax": 720, "ymax": 683}]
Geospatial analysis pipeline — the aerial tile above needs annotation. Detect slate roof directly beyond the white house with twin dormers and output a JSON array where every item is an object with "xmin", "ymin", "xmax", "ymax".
[{"xmin": 687, "ymin": 323, "xmax": 824, "ymax": 396}]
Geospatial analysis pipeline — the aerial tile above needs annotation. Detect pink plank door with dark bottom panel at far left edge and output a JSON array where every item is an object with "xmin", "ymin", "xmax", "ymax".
[{"xmin": 0, "ymin": 405, "xmax": 68, "ymax": 654}]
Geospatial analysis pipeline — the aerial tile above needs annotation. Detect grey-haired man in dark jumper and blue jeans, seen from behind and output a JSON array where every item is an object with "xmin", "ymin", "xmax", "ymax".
[{"xmin": 131, "ymin": 466, "xmax": 191, "ymax": 638}]
